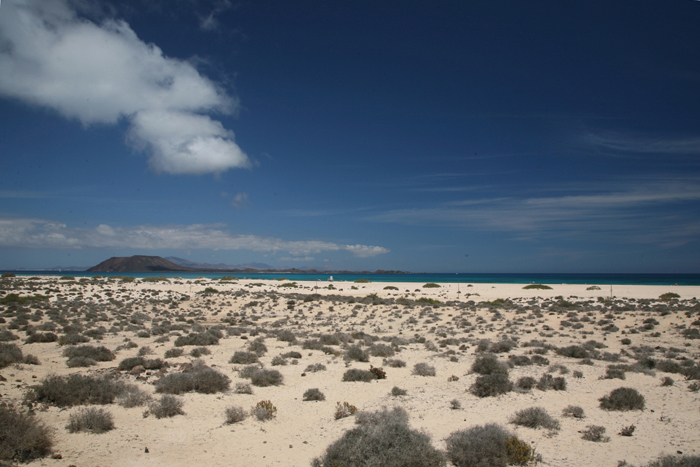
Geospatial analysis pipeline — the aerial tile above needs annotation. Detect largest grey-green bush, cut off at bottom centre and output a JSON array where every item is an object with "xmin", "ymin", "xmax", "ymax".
[{"xmin": 311, "ymin": 412, "xmax": 445, "ymax": 467}]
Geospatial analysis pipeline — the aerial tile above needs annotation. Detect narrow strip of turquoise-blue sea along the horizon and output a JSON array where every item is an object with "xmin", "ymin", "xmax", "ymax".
[{"xmin": 9, "ymin": 271, "xmax": 700, "ymax": 285}]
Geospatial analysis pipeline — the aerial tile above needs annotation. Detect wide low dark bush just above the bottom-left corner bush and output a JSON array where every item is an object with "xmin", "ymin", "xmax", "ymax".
[{"xmin": 26, "ymin": 374, "xmax": 123, "ymax": 407}]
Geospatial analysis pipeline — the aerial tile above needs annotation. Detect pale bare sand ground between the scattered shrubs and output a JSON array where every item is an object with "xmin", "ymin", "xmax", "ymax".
[{"xmin": 0, "ymin": 279, "xmax": 700, "ymax": 467}]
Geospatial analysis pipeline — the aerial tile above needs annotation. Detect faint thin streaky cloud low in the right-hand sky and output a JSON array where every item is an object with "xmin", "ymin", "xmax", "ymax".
[{"xmin": 368, "ymin": 179, "xmax": 700, "ymax": 243}]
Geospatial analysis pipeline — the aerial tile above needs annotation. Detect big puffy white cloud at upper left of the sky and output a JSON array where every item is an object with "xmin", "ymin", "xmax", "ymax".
[{"xmin": 0, "ymin": 0, "xmax": 251, "ymax": 174}]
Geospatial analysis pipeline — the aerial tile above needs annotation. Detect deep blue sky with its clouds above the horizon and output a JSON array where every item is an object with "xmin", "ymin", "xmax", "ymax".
[{"xmin": 0, "ymin": 0, "xmax": 700, "ymax": 273}]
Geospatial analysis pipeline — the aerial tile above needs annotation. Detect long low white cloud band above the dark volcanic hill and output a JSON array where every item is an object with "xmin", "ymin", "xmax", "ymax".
[{"xmin": 0, "ymin": 218, "xmax": 389, "ymax": 258}]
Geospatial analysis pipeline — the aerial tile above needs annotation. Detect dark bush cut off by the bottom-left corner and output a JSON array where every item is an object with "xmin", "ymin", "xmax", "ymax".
[{"xmin": 0, "ymin": 404, "xmax": 53, "ymax": 465}]
